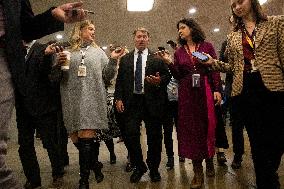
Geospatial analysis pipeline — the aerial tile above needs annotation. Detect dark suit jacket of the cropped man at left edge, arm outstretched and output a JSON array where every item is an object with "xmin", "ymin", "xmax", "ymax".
[{"xmin": 2, "ymin": 0, "xmax": 64, "ymax": 94}]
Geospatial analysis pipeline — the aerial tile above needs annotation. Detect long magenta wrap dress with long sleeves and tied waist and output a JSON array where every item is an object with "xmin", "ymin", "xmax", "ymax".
[{"xmin": 169, "ymin": 42, "xmax": 220, "ymax": 160}]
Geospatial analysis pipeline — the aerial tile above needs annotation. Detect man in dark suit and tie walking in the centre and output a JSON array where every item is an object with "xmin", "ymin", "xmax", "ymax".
[{"xmin": 115, "ymin": 28, "xmax": 171, "ymax": 183}]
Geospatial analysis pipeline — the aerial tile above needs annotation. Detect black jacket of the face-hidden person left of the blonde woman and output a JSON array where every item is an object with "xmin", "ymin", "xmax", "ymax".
[{"xmin": 16, "ymin": 42, "xmax": 61, "ymax": 116}]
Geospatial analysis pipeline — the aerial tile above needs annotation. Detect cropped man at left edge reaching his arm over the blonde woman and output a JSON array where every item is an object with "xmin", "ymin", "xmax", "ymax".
[{"xmin": 0, "ymin": 0, "xmax": 86, "ymax": 189}]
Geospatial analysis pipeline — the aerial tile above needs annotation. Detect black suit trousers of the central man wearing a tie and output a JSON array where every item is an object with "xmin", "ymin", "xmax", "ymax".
[{"xmin": 124, "ymin": 95, "xmax": 163, "ymax": 170}]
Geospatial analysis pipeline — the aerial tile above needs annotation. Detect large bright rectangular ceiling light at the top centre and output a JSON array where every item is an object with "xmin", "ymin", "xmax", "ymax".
[{"xmin": 127, "ymin": 0, "xmax": 154, "ymax": 12}]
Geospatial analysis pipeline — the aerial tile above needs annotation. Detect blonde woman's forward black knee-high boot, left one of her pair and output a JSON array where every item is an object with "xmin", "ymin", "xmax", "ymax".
[{"xmin": 78, "ymin": 138, "xmax": 94, "ymax": 189}]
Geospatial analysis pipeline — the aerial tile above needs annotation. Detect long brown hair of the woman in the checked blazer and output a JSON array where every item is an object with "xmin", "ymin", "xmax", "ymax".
[{"xmin": 231, "ymin": 0, "xmax": 267, "ymax": 31}]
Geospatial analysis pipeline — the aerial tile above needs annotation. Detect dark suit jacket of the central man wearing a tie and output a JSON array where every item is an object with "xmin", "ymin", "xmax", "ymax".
[{"xmin": 115, "ymin": 51, "xmax": 171, "ymax": 117}]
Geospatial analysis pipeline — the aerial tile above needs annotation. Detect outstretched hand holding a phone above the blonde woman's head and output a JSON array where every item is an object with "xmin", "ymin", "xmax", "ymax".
[{"xmin": 51, "ymin": 1, "xmax": 86, "ymax": 23}]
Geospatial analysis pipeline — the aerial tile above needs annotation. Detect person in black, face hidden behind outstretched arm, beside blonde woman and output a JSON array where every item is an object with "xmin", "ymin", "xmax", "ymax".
[{"xmin": 15, "ymin": 41, "xmax": 68, "ymax": 188}]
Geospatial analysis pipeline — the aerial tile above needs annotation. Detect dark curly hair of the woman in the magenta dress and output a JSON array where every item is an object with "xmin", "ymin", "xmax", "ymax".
[{"xmin": 177, "ymin": 18, "xmax": 206, "ymax": 45}]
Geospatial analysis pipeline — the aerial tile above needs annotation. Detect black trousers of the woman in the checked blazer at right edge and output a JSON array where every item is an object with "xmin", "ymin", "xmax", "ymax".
[{"xmin": 239, "ymin": 73, "xmax": 284, "ymax": 189}]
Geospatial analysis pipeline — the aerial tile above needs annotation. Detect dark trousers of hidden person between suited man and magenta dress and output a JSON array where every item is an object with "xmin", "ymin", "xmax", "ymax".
[{"xmin": 163, "ymin": 101, "xmax": 178, "ymax": 157}]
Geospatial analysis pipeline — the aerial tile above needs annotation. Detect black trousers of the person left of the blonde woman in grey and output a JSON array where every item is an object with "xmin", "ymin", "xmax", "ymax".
[{"xmin": 16, "ymin": 108, "xmax": 64, "ymax": 184}]
